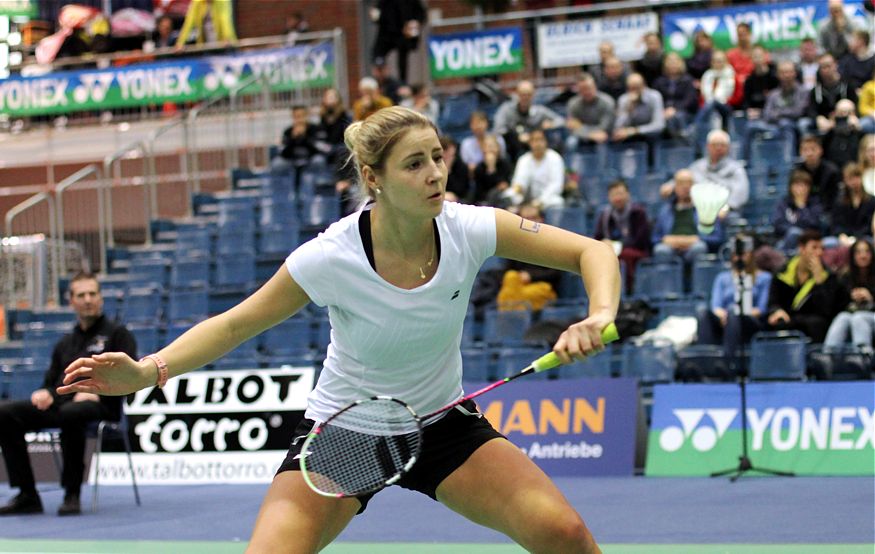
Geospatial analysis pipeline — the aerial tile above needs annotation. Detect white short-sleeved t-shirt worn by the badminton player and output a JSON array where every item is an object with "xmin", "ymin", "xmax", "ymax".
[{"xmin": 286, "ymin": 202, "xmax": 496, "ymax": 421}]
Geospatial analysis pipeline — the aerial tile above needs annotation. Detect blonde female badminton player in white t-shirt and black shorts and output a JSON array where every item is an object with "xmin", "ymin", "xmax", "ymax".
[{"xmin": 58, "ymin": 107, "xmax": 620, "ymax": 554}]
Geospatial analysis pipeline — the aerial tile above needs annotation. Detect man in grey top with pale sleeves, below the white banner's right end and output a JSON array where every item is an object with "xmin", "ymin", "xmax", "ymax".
[{"xmin": 611, "ymin": 73, "xmax": 665, "ymax": 165}]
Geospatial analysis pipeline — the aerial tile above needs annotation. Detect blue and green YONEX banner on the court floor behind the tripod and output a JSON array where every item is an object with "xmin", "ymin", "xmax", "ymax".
[{"xmin": 646, "ymin": 381, "xmax": 875, "ymax": 476}]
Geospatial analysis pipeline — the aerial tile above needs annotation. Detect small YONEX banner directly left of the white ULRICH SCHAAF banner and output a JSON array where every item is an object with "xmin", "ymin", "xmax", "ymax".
[{"xmin": 428, "ymin": 27, "xmax": 523, "ymax": 79}]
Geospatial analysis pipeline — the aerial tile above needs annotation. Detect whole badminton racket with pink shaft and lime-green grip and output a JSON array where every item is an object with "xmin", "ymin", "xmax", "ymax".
[{"xmin": 301, "ymin": 323, "xmax": 619, "ymax": 498}]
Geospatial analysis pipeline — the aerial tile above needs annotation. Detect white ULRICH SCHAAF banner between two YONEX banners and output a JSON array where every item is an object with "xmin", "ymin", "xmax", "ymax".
[{"xmin": 538, "ymin": 12, "xmax": 659, "ymax": 67}]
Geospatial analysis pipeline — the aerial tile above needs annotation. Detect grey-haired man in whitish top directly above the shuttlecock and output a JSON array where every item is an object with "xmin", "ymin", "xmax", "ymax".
[{"xmin": 690, "ymin": 129, "xmax": 750, "ymax": 212}]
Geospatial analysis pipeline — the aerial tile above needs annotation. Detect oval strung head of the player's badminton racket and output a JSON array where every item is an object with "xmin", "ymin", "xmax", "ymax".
[{"xmin": 302, "ymin": 399, "xmax": 420, "ymax": 496}]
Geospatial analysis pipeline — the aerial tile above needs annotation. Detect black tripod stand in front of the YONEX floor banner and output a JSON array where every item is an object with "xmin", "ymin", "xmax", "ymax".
[{"xmin": 711, "ymin": 237, "xmax": 796, "ymax": 483}]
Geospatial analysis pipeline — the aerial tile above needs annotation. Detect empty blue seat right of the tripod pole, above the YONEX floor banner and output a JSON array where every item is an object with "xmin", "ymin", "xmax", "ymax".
[{"xmin": 748, "ymin": 331, "xmax": 811, "ymax": 380}]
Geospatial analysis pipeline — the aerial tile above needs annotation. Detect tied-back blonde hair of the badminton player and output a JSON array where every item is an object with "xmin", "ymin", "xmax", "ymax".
[{"xmin": 343, "ymin": 106, "xmax": 438, "ymax": 199}]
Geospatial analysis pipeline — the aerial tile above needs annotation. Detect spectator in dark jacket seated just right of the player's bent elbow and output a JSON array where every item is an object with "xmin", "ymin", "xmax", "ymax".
[{"xmin": 593, "ymin": 179, "xmax": 650, "ymax": 293}]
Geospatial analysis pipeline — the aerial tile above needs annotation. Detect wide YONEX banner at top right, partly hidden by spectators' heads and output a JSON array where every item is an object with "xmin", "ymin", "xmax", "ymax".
[{"xmin": 662, "ymin": 0, "xmax": 871, "ymax": 56}]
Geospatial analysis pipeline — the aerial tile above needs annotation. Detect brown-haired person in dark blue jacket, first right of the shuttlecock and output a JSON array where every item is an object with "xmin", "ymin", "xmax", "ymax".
[{"xmin": 772, "ymin": 170, "xmax": 823, "ymax": 252}]
